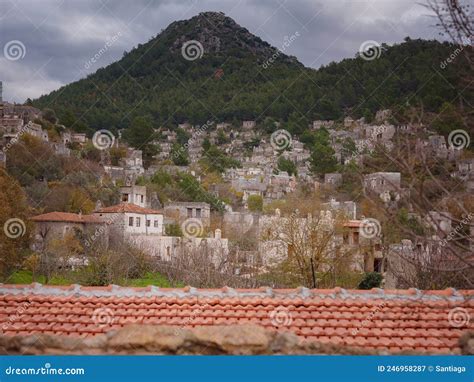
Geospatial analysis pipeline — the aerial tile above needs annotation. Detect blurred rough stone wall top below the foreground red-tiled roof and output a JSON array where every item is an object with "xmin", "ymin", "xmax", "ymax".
[{"xmin": 4, "ymin": 325, "xmax": 474, "ymax": 355}]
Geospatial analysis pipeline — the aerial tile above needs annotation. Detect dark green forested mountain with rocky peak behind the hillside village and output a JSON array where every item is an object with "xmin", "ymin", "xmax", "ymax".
[{"xmin": 33, "ymin": 12, "xmax": 468, "ymax": 132}]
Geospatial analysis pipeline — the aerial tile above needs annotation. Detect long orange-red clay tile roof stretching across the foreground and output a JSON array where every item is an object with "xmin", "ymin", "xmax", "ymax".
[{"xmin": 0, "ymin": 284, "xmax": 474, "ymax": 354}]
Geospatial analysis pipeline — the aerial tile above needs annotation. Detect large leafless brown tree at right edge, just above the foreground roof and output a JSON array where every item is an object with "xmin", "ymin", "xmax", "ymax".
[{"xmin": 359, "ymin": 133, "xmax": 474, "ymax": 289}]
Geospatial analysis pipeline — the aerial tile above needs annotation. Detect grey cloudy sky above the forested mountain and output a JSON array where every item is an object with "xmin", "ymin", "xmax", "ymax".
[{"xmin": 0, "ymin": 0, "xmax": 439, "ymax": 102}]
